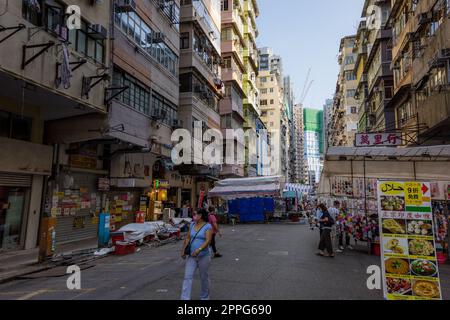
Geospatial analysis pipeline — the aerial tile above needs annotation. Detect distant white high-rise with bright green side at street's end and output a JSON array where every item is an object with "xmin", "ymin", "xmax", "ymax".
[{"xmin": 303, "ymin": 108, "xmax": 324, "ymax": 187}]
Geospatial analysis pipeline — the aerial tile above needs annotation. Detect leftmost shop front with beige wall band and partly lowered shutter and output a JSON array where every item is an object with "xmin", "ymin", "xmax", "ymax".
[{"xmin": 0, "ymin": 137, "xmax": 53, "ymax": 252}]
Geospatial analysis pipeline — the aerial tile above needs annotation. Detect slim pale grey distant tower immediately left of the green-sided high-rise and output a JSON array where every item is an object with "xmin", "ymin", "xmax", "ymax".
[{"xmin": 291, "ymin": 104, "xmax": 308, "ymax": 183}]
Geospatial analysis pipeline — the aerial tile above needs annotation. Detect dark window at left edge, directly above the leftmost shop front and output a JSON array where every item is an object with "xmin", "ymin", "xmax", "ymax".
[{"xmin": 0, "ymin": 110, "xmax": 33, "ymax": 141}]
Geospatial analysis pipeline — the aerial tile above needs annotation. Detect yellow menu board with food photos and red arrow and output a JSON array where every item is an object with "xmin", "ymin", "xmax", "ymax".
[{"xmin": 378, "ymin": 181, "xmax": 442, "ymax": 300}]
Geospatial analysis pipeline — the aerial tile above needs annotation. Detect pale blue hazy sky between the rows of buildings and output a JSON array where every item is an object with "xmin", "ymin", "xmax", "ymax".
[{"xmin": 257, "ymin": 0, "xmax": 364, "ymax": 108}]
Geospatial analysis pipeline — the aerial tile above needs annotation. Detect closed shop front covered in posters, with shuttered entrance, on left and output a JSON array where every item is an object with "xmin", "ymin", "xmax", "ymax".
[{"xmin": 45, "ymin": 142, "xmax": 109, "ymax": 245}]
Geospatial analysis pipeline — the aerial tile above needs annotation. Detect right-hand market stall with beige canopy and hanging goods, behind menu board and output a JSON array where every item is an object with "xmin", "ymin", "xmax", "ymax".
[{"xmin": 317, "ymin": 146, "xmax": 450, "ymax": 254}]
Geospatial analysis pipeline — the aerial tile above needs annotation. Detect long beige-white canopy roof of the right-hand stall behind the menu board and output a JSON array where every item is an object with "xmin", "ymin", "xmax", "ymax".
[{"xmin": 317, "ymin": 145, "xmax": 450, "ymax": 195}]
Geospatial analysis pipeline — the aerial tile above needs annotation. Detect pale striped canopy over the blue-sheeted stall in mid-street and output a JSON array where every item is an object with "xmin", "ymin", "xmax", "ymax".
[{"xmin": 208, "ymin": 176, "xmax": 283, "ymax": 199}]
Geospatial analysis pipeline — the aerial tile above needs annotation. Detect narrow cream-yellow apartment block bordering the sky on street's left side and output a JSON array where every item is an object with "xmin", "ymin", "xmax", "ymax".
[{"xmin": 240, "ymin": 0, "xmax": 263, "ymax": 177}]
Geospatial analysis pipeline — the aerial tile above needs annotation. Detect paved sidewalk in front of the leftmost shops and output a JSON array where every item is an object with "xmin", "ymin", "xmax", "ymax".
[{"xmin": 0, "ymin": 239, "xmax": 98, "ymax": 283}]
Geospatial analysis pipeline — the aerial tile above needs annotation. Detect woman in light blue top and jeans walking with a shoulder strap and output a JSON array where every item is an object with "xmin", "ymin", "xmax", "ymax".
[{"xmin": 181, "ymin": 209, "xmax": 212, "ymax": 300}]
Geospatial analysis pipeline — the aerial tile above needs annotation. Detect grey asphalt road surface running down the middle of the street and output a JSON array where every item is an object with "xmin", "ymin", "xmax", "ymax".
[{"xmin": 0, "ymin": 225, "xmax": 450, "ymax": 300}]
